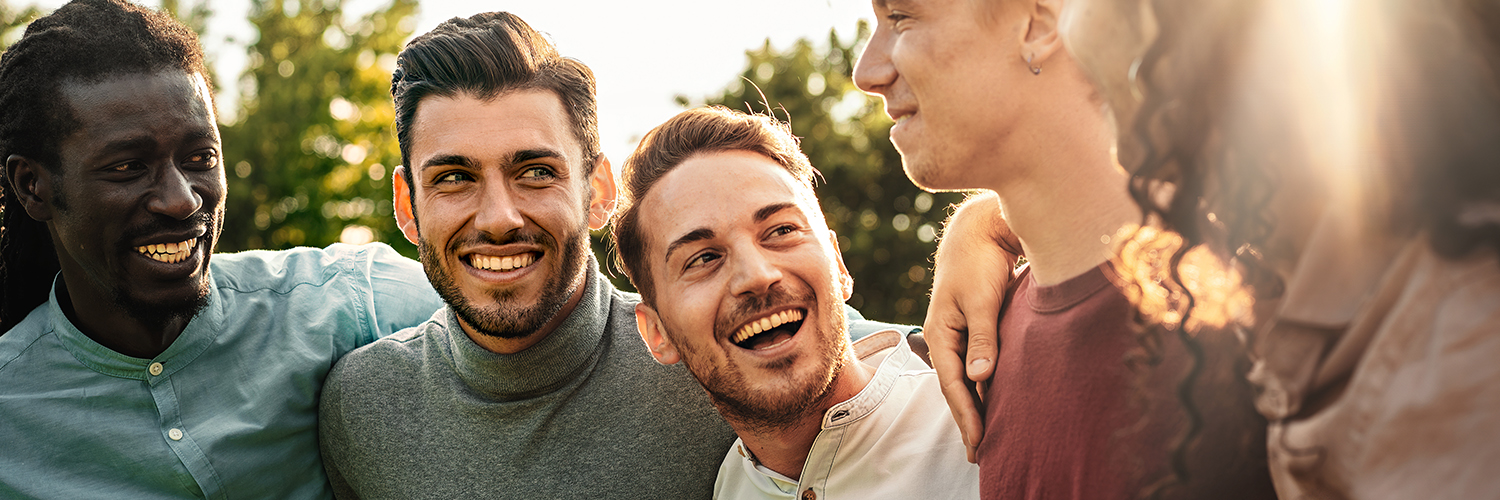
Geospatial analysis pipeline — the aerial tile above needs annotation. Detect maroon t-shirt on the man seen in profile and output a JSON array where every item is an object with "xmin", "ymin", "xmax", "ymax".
[{"xmin": 980, "ymin": 264, "xmax": 1181, "ymax": 500}]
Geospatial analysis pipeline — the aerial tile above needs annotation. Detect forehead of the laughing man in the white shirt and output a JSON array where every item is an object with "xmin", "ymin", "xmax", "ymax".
[{"xmin": 641, "ymin": 150, "xmax": 819, "ymax": 247}]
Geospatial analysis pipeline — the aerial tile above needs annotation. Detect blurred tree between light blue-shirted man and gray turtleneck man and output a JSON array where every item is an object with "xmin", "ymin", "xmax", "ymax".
[{"xmin": 219, "ymin": 0, "xmax": 417, "ymax": 257}]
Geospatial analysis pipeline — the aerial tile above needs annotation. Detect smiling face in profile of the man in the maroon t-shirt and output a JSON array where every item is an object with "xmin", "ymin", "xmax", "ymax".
[{"xmin": 854, "ymin": 0, "xmax": 1035, "ymax": 189}]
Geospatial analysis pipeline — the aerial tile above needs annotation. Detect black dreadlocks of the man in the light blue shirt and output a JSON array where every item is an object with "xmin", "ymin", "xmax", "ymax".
[{"xmin": 0, "ymin": 0, "xmax": 209, "ymax": 332}]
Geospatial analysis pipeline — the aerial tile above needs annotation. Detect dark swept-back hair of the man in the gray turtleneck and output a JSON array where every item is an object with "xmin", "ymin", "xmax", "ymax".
[{"xmin": 390, "ymin": 12, "xmax": 600, "ymax": 204}]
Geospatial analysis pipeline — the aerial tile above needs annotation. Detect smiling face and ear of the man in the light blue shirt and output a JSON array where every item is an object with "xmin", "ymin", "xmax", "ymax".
[{"xmin": 5, "ymin": 69, "xmax": 227, "ymax": 359}]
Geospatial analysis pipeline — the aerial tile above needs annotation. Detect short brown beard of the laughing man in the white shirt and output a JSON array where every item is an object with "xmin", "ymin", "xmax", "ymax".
[{"xmin": 668, "ymin": 285, "xmax": 849, "ymax": 434}]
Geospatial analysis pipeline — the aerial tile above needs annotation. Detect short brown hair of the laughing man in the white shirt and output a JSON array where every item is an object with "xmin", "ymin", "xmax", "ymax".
[{"xmin": 612, "ymin": 105, "xmax": 818, "ymax": 305}]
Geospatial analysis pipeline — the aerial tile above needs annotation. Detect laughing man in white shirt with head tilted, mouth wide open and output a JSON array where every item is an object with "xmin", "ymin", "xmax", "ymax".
[{"xmin": 614, "ymin": 108, "xmax": 978, "ymax": 498}]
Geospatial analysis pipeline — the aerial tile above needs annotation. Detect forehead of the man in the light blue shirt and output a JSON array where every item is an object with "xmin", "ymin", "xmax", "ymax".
[{"xmin": 60, "ymin": 69, "xmax": 219, "ymax": 151}]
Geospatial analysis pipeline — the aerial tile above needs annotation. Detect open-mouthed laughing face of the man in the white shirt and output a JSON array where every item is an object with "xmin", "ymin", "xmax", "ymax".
[{"xmin": 638, "ymin": 150, "xmax": 858, "ymax": 428}]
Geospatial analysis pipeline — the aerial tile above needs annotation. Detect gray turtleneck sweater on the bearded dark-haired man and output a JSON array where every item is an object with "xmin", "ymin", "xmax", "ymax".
[{"xmin": 319, "ymin": 263, "xmax": 735, "ymax": 498}]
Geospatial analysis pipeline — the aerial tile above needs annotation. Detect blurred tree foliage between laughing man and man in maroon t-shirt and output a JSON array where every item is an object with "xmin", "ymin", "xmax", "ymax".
[{"xmin": 645, "ymin": 23, "xmax": 962, "ymax": 324}]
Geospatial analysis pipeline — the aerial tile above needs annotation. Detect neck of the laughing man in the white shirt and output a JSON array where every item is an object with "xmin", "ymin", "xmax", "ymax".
[{"xmin": 725, "ymin": 350, "xmax": 875, "ymax": 479}]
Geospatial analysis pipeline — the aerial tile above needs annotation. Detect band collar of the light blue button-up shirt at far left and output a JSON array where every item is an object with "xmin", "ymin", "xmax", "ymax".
[{"xmin": 47, "ymin": 264, "xmax": 224, "ymax": 384}]
